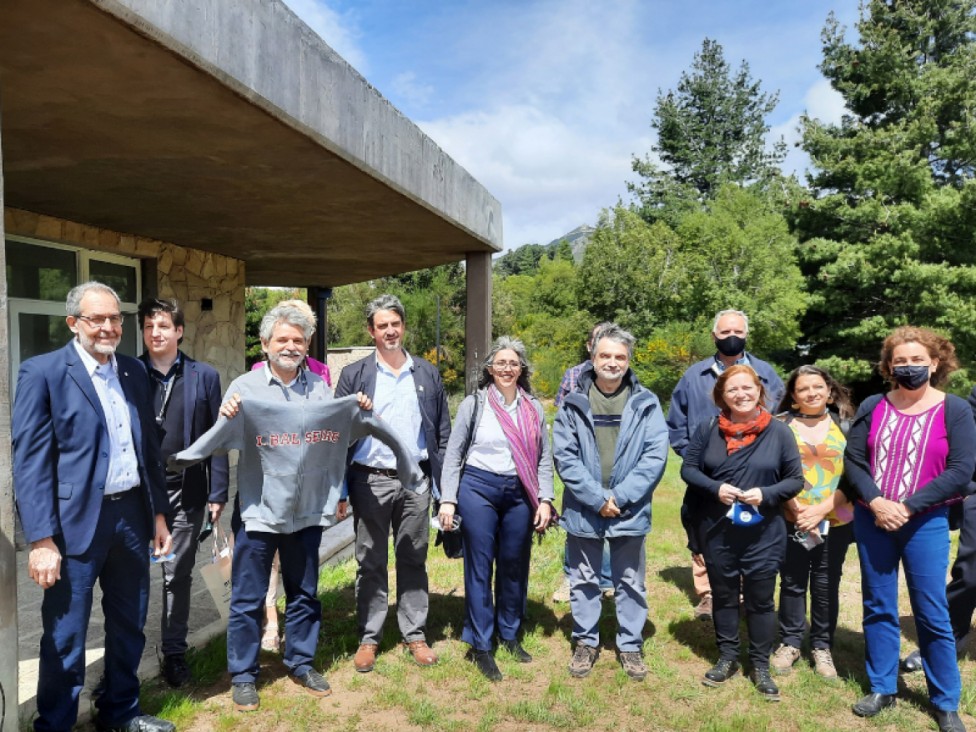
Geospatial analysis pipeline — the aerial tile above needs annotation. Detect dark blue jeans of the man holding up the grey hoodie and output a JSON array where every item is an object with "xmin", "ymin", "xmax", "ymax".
[{"xmin": 227, "ymin": 526, "xmax": 322, "ymax": 684}]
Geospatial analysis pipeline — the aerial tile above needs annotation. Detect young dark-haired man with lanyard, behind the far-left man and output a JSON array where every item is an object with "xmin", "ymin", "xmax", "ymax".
[{"xmin": 138, "ymin": 297, "xmax": 227, "ymax": 688}]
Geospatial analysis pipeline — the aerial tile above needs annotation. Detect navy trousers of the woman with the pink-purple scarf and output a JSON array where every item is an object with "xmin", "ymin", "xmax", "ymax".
[{"xmin": 457, "ymin": 466, "xmax": 532, "ymax": 651}]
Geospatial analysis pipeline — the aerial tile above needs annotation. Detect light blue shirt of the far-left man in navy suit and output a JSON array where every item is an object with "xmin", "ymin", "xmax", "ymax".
[{"xmin": 74, "ymin": 340, "xmax": 140, "ymax": 495}]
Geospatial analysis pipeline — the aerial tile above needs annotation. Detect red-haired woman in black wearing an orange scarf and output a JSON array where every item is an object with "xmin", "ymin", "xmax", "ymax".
[{"xmin": 681, "ymin": 365, "xmax": 803, "ymax": 701}]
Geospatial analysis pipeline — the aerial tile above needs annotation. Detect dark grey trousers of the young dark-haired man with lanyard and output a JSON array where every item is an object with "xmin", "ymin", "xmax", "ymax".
[{"xmin": 160, "ymin": 505, "xmax": 207, "ymax": 656}]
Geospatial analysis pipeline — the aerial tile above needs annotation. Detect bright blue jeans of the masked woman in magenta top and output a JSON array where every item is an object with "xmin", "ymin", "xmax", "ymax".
[{"xmin": 854, "ymin": 505, "xmax": 961, "ymax": 711}]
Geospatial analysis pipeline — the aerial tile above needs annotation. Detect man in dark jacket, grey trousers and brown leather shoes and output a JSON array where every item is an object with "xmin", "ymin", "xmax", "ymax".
[{"xmin": 336, "ymin": 295, "xmax": 451, "ymax": 673}]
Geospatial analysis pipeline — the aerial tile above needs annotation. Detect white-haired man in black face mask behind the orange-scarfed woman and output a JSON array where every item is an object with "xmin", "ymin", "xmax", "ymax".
[{"xmin": 668, "ymin": 310, "xmax": 784, "ymax": 621}]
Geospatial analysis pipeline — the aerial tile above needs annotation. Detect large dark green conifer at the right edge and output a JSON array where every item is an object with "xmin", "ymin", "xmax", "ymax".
[{"xmin": 792, "ymin": 0, "xmax": 976, "ymax": 383}]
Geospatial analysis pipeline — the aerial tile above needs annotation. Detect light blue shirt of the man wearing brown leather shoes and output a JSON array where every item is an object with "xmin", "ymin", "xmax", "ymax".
[{"xmin": 352, "ymin": 353, "xmax": 427, "ymax": 470}]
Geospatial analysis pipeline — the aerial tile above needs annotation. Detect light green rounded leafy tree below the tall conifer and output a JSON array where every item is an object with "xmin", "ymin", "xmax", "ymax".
[{"xmin": 577, "ymin": 185, "xmax": 806, "ymax": 353}]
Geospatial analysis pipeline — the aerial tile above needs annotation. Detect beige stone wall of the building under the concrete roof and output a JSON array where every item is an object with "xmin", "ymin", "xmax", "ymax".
[{"xmin": 4, "ymin": 208, "xmax": 245, "ymax": 387}]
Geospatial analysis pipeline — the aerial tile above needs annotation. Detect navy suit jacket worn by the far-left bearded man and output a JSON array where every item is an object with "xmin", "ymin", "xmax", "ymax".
[{"xmin": 13, "ymin": 341, "xmax": 169, "ymax": 555}]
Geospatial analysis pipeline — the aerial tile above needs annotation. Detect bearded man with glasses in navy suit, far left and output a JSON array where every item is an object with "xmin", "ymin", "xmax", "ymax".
[{"xmin": 13, "ymin": 282, "xmax": 176, "ymax": 732}]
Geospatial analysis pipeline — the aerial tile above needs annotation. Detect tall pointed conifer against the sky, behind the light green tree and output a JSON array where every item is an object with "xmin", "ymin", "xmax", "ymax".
[{"xmin": 627, "ymin": 38, "xmax": 786, "ymax": 223}]
